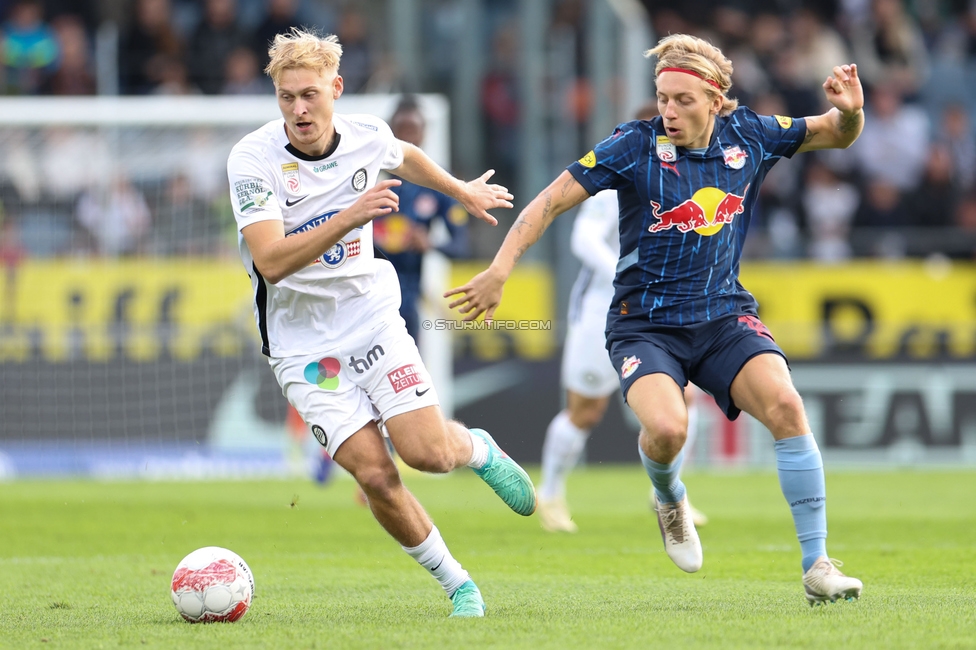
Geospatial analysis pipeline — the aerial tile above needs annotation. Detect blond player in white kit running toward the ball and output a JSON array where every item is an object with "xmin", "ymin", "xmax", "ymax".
[{"xmin": 227, "ymin": 29, "xmax": 535, "ymax": 617}]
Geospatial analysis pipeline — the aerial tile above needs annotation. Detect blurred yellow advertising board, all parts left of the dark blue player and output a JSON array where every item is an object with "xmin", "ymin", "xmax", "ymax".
[{"xmin": 0, "ymin": 259, "xmax": 556, "ymax": 362}]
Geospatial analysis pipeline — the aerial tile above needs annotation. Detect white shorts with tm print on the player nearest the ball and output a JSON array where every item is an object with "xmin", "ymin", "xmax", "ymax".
[{"xmin": 270, "ymin": 320, "xmax": 439, "ymax": 456}]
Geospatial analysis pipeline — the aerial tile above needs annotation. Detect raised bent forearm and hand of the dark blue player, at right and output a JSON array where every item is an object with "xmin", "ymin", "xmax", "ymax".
[{"xmin": 797, "ymin": 63, "xmax": 864, "ymax": 152}]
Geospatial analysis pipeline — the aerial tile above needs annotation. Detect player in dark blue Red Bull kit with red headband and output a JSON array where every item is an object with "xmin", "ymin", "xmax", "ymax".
[{"xmin": 445, "ymin": 34, "xmax": 864, "ymax": 604}]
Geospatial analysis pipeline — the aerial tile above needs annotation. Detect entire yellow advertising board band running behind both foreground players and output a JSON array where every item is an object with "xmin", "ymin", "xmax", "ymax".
[{"xmin": 0, "ymin": 260, "xmax": 976, "ymax": 362}]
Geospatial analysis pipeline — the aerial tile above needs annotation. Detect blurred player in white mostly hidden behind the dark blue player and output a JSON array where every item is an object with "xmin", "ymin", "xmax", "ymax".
[{"xmin": 539, "ymin": 102, "xmax": 708, "ymax": 533}]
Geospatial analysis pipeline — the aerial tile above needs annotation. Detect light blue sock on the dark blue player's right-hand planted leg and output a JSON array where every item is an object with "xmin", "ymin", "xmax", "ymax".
[{"xmin": 774, "ymin": 435, "xmax": 827, "ymax": 572}]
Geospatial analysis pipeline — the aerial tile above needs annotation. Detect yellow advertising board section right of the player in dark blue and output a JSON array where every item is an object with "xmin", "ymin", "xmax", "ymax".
[{"xmin": 740, "ymin": 261, "xmax": 976, "ymax": 359}]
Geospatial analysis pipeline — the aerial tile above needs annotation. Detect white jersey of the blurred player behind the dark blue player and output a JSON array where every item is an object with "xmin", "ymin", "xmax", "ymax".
[{"xmin": 569, "ymin": 190, "xmax": 620, "ymax": 323}]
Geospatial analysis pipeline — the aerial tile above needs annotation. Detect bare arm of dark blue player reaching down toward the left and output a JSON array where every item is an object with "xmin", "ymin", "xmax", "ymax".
[{"xmin": 444, "ymin": 171, "xmax": 590, "ymax": 321}]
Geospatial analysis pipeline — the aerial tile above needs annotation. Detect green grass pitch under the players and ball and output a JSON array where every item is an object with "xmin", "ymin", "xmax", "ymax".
[{"xmin": 0, "ymin": 465, "xmax": 976, "ymax": 650}]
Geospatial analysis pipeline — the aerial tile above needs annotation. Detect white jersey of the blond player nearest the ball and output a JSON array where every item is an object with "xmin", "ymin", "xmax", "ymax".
[{"xmin": 227, "ymin": 115, "xmax": 403, "ymax": 357}]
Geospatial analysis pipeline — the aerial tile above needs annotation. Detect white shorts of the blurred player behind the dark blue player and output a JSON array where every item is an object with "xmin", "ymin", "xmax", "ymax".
[{"xmin": 562, "ymin": 300, "xmax": 620, "ymax": 398}]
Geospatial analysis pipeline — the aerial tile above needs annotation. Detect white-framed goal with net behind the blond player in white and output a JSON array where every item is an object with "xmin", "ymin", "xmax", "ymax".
[{"xmin": 0, "ymin": 95, "xmax": 452, "ymax": 478}]
